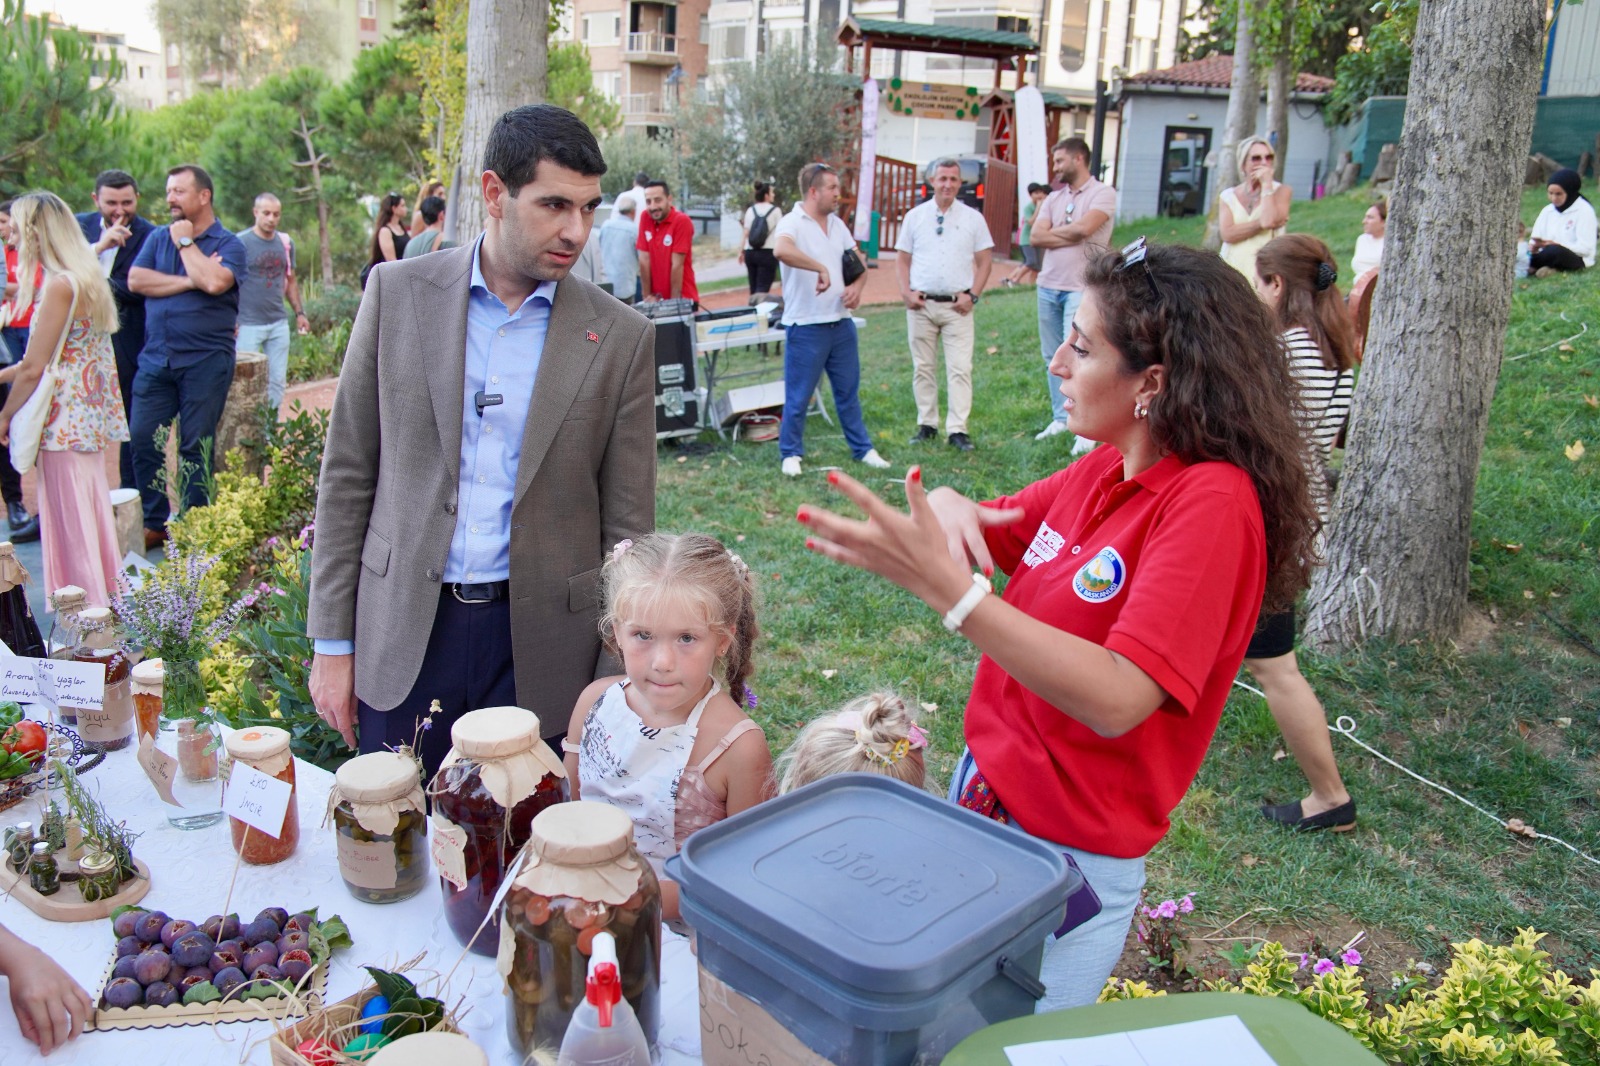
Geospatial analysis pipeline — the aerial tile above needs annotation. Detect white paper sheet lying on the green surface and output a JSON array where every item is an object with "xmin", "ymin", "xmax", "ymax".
[{"xmin": 1005, "ymin": 1015, "xmax": 1277, "ymax": 1066}]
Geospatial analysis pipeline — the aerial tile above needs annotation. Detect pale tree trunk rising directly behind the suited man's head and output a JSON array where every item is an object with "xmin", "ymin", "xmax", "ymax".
[{"xmin": 456, "ymin": 0, "xmax": 550, "ymax": 242}]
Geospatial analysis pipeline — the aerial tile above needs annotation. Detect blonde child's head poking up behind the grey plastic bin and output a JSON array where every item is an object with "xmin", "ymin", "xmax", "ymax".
[{"xmin": 776, "ymin": 691, "xmax": 928, "ymax": 795}]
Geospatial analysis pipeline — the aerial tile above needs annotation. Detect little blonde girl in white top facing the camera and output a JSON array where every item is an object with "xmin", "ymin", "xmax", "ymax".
[{"xmin": 563, "ymin": 533, "xmax": 773, "ymax": 919}]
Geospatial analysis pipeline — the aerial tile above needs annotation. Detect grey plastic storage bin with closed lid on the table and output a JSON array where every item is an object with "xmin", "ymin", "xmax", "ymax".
[{"xmin": 667, "ymin": 773, "xmax": 1083, "ymax": 1066}]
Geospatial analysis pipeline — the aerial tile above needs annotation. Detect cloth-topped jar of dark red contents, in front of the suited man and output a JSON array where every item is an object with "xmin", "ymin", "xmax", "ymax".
[{"xmin": 429, "ymin": 707, "xmax": 566, "ymax": 956}]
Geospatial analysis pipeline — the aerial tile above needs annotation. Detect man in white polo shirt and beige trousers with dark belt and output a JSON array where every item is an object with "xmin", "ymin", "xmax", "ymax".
[{"xmin": 894, "ymin": 158, "xmax": 995, "ymax": 451}]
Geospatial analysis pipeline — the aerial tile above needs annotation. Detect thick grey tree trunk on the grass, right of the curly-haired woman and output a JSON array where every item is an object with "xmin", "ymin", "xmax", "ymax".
[{"xmin": 1306, "ymin": 0, "xmax": 1544, "ymax": 648}]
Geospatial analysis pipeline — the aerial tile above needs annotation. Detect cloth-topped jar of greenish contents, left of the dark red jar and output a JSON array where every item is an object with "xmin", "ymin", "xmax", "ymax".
[{"xmin": 328, "ymin": 751, "xmax": 429, "ymax": 903}]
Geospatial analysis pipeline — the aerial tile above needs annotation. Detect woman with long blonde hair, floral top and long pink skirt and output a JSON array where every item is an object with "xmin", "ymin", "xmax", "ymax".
[{"xmin": 0, "ymin": 192, "xmax": 128, "ymax": 607}]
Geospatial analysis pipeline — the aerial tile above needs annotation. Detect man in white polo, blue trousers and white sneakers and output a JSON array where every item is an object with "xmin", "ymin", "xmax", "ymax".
[{"xmin": 773, "ymin": 163, "xmax": 888, "ymax": 477}]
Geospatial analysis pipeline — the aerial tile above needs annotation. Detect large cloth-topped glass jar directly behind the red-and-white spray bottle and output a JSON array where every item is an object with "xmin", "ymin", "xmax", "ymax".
[{"xmin": 496, "ymin": 802, "xmax": 661, "ymax": 1058}]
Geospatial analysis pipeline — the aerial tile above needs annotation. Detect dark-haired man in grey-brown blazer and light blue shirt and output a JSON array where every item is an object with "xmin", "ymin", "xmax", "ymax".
[{"xmin": 306, "ymin": 104, "xmax": 656, "ymax": 773}]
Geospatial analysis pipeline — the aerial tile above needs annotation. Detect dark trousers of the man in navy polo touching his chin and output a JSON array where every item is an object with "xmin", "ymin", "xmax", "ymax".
[{"xmin": 128, "ymin": 351, "xmax": 234, "ymax": 530}]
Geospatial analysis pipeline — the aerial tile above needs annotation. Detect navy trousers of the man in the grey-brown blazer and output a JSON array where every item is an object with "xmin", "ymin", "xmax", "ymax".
[{"xmin": 357, "ymin": 586, "xmax": 517, "ymax": 779}]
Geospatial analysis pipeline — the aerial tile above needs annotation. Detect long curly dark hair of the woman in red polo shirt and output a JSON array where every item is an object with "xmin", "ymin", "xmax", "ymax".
[{"xmin": 1085, "ymin": 245, "xmax": 1320, "ymax": 610}]
